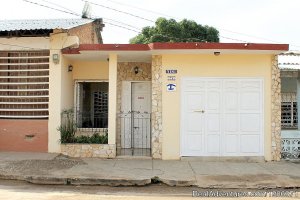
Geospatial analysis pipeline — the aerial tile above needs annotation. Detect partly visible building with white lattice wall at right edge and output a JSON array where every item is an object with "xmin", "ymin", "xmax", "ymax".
[{"xmin": 278, "ymin": 52, "xmax": 300, "ymax": 159}]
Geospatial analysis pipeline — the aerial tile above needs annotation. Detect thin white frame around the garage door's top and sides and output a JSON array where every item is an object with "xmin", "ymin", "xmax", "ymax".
[{"xmin": 180, "ymin": 77, "xmax": 265, "ymax": 157}]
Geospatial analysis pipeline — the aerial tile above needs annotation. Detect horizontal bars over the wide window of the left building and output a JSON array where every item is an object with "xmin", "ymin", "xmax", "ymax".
[{"xmin": 0, "ymin": 51, "xmax": 49, "ymax": 119}]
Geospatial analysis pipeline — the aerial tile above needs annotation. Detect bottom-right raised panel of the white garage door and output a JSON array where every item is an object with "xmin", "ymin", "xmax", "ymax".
[{"xmin": 240, "ymin": 134, "xmax": 261, "ymax": 154}]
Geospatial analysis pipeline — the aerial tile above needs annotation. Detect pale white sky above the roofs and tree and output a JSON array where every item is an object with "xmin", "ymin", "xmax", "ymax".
[{"xmin": 0, "ymin": 0, "xmax": 300, "ymax": 51}]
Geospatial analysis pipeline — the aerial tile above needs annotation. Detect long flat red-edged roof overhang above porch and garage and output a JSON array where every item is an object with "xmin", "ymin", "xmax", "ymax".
[{"xmin": 62, "ymin": 43, "xmax": 289, "ymax": 62}]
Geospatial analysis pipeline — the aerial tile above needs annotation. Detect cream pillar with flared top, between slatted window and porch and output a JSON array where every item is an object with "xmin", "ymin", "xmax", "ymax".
[{"xmin": 48, "ymin": 33, "xmax": 78, "ymax": 153}]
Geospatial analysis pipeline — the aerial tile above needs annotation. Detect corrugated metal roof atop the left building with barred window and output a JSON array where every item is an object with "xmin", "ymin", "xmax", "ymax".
[{"xmin": 0, "ymin": 19, "xmax": 94, "ymax": 31}]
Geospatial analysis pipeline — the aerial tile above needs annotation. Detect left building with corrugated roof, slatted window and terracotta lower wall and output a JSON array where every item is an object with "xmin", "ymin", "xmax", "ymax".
[{"xmin": 0, "ymin": 19, "xmax": 104, "ymax": 152}]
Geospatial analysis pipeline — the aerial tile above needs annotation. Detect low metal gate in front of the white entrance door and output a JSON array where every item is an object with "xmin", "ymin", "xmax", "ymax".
[{"xmin": 117, "ymin": 111, "xmax": 151, "ymax": 156}]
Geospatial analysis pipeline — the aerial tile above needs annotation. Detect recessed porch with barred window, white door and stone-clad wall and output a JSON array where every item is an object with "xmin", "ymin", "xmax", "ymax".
[{"xmin": 56, "ymin": 49, "xmax": 162, "ymax": 158}]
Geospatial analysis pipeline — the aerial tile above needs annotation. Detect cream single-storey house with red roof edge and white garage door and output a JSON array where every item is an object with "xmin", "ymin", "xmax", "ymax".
[{"xmin": 59, "ymin": 43, "xmax": 288, "ymax": 161}]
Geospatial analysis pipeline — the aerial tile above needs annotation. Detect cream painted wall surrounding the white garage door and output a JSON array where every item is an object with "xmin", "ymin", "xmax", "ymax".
[{"xmin": 162, "ymin": 55, "xmax": 271, "ymax": 160}]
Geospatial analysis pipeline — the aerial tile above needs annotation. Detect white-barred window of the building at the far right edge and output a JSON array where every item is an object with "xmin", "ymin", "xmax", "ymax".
[{"xmin": 281, "ymin": 93, "xmax": 298, "ymax": 129}]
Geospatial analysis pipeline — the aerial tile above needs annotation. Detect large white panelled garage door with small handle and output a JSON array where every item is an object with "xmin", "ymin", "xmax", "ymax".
[{"xmin": 181, "ymin": 78, "xmax": 264, "ymax": 156}]
